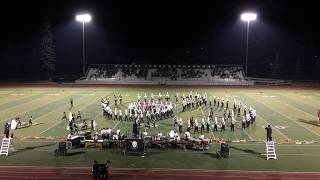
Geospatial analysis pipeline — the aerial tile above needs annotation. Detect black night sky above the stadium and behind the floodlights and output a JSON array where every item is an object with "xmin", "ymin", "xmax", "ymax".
[{"xmin": 0, "ymin": 0, "xmax": 320, "ymax": 78}]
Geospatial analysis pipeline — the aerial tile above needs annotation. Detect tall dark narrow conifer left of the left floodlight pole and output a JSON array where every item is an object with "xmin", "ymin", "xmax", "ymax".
[{"xmin": 40, "ymin": 18, "xmax": 56, "ymax": 81}]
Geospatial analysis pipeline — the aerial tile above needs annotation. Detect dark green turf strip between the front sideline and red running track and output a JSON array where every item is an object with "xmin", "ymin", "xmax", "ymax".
[{"xmin": 0, "ymin": 141, "xmax": 320, "ymax": 172}]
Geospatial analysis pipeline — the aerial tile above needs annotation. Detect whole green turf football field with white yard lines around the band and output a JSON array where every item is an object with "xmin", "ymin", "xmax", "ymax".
[{"xmin": 0, "ymin": 87, "xmax": 320, "ymax": 171}]
